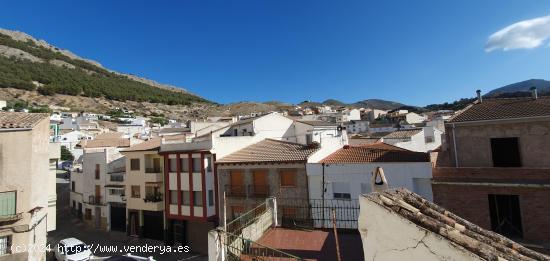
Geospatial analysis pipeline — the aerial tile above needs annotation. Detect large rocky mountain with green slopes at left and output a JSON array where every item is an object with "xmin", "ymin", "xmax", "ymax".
[{"xmin": 0, "ymin": 29, "xmax": 210, "ymax": 105}]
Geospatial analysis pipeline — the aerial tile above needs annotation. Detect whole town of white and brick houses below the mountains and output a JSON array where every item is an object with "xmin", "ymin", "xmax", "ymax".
[{"xmin": 0, "ymin": 88, "xmax": 550, "ymax": 260}]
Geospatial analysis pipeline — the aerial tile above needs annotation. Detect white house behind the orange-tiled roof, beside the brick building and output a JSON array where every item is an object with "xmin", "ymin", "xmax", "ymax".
[{"xmin": 381, "ymin": 126, "xmax": 443, "ymax": 152}]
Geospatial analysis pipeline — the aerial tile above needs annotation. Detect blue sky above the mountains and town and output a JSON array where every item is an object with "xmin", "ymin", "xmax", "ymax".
[{"xmin": 0, "ymin": 0, "xmax": 550, "ymax": 105}]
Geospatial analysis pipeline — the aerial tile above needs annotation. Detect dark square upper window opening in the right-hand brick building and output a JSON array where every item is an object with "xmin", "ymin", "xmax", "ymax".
[{"xmin": 491, "ymin": 138, "xmax": 521, "ymax": 167}]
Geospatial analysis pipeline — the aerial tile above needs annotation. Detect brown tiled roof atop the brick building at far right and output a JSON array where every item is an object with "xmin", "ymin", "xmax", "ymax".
[{"xmin": 449, "ymin": 97, "xmax": 550, "ymax": 122}]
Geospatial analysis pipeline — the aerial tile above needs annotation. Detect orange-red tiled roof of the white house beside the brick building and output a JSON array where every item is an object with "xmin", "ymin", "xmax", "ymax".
[{"xmin": 321, "ymin": 142, "xmax": 430, "ymax": 163}]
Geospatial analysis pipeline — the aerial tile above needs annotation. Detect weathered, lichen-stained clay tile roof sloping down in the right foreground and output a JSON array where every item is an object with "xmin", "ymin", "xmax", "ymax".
[{"xmin": 364, "ymin": 188, "xmax": 550, "ymax": 260}]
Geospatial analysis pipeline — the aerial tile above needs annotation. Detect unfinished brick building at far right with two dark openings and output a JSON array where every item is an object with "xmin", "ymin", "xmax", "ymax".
[{"xmin": 432, "ymin": 91, "xmax": 550, "ymax": 249}]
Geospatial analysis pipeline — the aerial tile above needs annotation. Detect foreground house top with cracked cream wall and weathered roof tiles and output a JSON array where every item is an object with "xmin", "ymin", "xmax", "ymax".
[{"xmin": 359, "ymin": 189, "xmax": 548, "ymax": 261}]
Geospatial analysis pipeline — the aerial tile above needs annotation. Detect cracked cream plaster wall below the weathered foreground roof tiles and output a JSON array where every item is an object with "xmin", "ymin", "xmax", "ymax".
[{"xmin": 359, "ymin": 197, "xmax": 483, "ymax": 261}]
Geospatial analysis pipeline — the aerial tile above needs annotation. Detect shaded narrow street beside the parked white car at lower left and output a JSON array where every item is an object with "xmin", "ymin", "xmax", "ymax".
[{"xmin": 48, "ymin": 174, "xmax": 208, "ymax": 260}]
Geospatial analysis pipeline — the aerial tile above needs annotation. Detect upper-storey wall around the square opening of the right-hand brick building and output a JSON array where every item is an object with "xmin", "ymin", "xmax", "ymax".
[{"xmin": 446, "ymin": 121, "xmax": 550, "ymax": 168}]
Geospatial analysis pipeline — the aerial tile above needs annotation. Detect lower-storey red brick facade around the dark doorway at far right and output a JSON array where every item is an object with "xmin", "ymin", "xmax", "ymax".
[{"xmin": 432, "ymin": 168, "xmax": 550, "ymax": 247}]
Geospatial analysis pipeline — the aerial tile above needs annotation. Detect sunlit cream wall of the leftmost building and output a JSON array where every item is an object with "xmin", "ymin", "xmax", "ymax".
[{"xmin": 0, "ymin": 117, "xmax": 50, "ymax": 260}]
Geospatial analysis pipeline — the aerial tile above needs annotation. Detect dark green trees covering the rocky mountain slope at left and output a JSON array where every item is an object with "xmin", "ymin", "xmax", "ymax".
[{"xmin": 0, "ymin": 34, "xmax": 208, "ymax": 105}]
